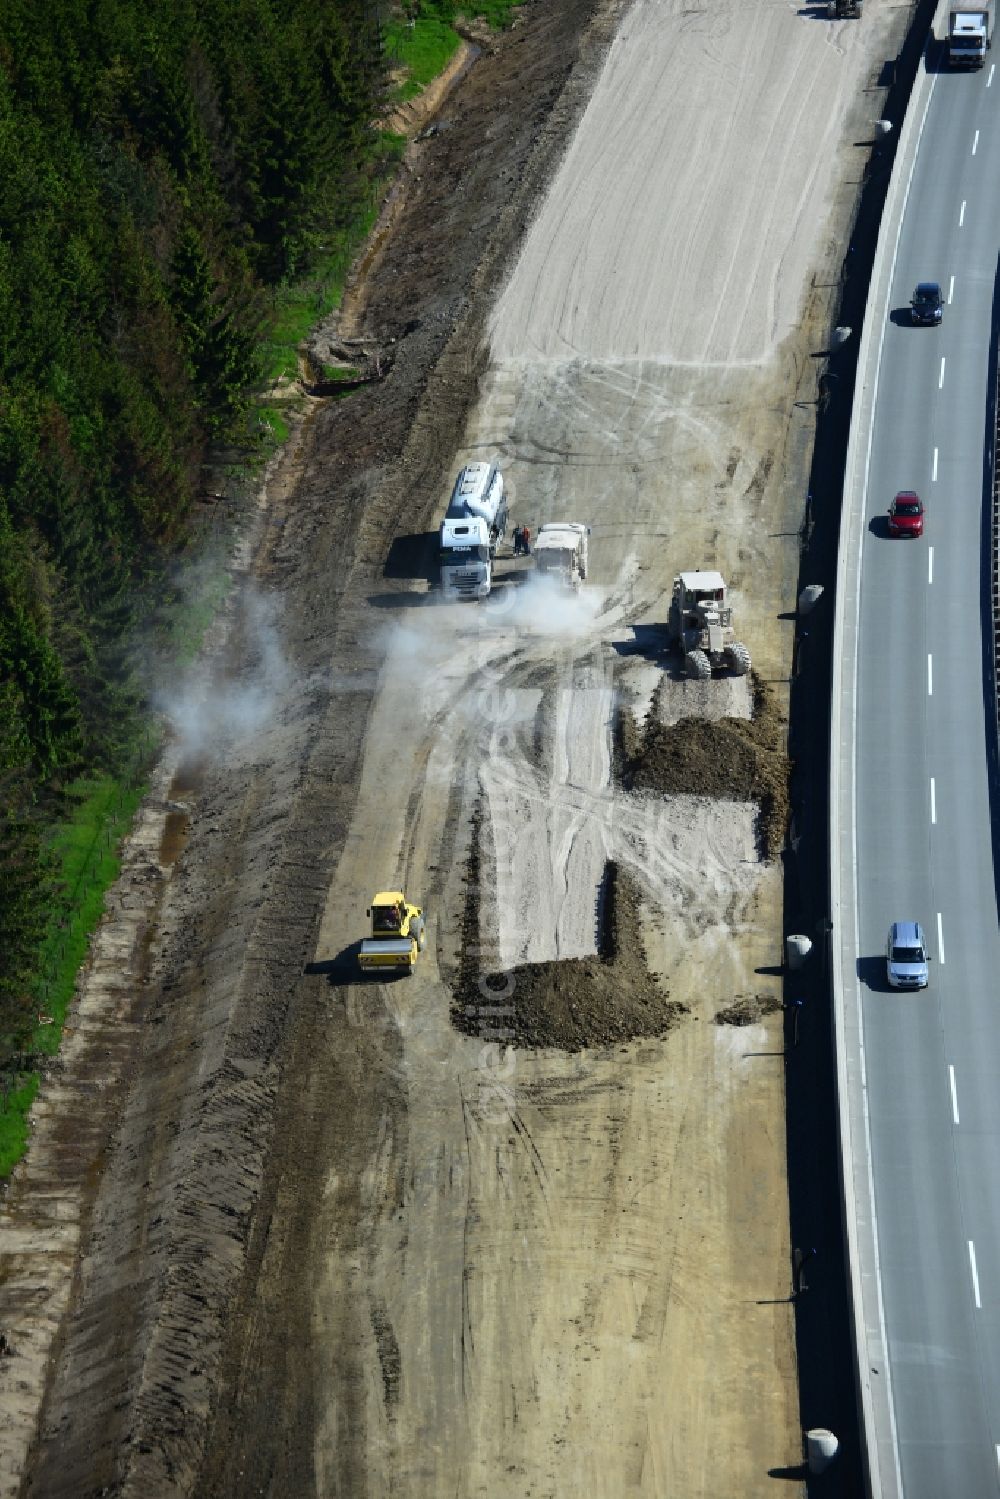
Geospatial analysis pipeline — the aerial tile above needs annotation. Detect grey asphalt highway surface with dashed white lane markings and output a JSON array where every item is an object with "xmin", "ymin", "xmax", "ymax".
[{"xmin": 853, "ymin": 48, "xmax": 1000, "ymax": 1499}]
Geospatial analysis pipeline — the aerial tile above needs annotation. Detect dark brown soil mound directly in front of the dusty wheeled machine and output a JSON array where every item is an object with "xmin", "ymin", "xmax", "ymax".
[{"xmin": 619, "ymin": 673, "xmax": 790, "ymax": 859}]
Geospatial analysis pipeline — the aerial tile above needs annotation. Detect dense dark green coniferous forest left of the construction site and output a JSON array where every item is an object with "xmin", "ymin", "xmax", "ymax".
[{"xmin": 0, "ymin": 0, "xmax": 451, "ymax": 1064}]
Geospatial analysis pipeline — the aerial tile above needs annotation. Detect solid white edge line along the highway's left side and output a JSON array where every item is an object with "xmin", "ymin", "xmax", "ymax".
[{"xmin": 831, "ymin": 35, "xmax": 941, "ymax": 1499}]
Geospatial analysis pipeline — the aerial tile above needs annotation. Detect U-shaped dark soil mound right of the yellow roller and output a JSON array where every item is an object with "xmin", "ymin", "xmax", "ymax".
[{"xmin": 451, "ymin": 857, "xmax": 687, "ymax": 1051}]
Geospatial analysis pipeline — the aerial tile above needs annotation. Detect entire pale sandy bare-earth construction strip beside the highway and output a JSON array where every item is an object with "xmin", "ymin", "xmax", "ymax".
[{"xmin": 302, "ymin": 0, "xmax": 899, "ymax": 1499}]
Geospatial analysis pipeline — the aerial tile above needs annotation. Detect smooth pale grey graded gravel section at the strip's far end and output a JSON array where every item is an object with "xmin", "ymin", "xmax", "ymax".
[{"xmin": 493, "ymin": 0, "xmax": 871, "ymax": 364}]
